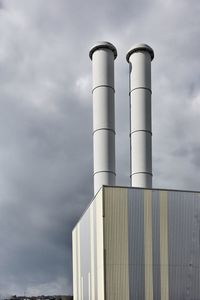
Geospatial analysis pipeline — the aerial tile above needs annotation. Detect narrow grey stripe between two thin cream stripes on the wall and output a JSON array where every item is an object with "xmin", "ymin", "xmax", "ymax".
[{"xmin": 152, "ymin": 191, "xmax": 161, "ymax": 300}]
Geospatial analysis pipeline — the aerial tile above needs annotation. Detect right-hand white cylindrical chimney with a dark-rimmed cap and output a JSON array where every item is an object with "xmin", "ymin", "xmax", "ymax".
[{"xmin": 126, "ymin": 44, "xmax": 154, "ymax": 188}]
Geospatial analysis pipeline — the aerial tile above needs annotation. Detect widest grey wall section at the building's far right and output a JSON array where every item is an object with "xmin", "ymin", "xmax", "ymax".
[{"xmin": 168, "ymin": 192, "xmax": 200, "ymax": 300}]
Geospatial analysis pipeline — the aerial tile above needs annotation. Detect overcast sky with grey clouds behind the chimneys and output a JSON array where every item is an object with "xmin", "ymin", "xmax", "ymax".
[{"xmin": 0, "ymin": 0, "xmax": 200, "ymax": 295}]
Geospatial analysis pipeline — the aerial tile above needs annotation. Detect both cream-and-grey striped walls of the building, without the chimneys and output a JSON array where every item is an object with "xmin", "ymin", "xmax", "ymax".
[{"xmin": 73, "ymin": 186, "xmax": 200, "ymax": 300}]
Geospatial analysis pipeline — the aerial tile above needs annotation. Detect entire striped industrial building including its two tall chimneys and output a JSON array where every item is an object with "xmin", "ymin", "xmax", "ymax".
[{"xmin": 72, "ymin": 42, "xmax": 200, "ymax": 300}]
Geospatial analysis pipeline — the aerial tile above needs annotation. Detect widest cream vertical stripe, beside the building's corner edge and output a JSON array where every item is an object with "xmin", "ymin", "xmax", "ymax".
[{"xmin": 104, "ymin": 187, "xmax": 129, "ymax": 300}]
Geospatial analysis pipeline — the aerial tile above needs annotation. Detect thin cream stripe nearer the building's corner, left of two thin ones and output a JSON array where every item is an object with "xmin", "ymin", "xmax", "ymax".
[{"xmin": 144, "ymin": 190, "xmax": 153, "ymax": 300}]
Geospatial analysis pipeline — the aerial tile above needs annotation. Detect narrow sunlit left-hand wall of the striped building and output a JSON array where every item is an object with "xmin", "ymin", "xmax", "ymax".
[{"xmin": 72, "ymin": 190, "xmax": 105, "ymax": 300}]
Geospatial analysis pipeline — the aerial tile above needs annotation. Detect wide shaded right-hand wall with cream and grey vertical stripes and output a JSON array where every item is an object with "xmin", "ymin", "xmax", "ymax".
[{"xmin": 104, "ymin": 187, "xmax": 200, "ymax": 300}]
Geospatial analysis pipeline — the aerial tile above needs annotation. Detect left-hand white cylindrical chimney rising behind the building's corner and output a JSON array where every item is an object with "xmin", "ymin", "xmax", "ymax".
[{"xmin": 89, "ymin": 42, "xmax": 117, "ymax": 194}]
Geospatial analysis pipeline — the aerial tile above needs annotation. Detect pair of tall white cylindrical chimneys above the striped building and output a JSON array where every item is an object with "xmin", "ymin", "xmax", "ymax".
[{"xmin": 89, "ymin": 42, "xmax": 154, "ymax": 194}]
